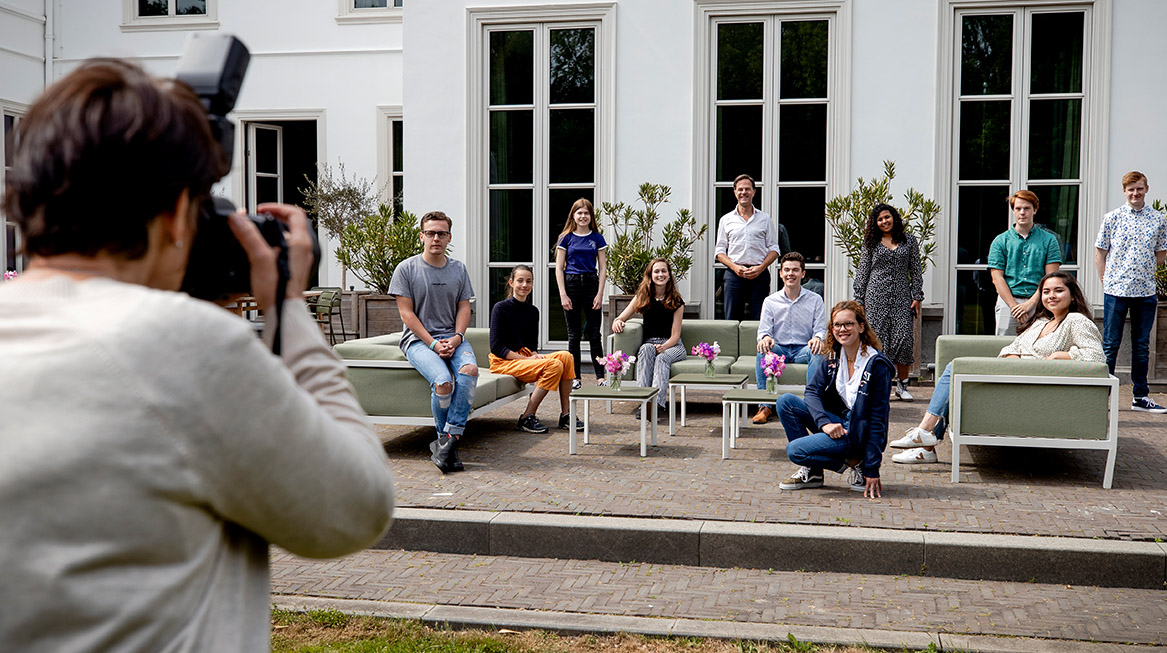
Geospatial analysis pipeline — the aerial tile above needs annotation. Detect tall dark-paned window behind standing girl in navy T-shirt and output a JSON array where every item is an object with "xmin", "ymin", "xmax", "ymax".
[{"xmin": 480, "ymin": 23, "xmax": 599, "ymax": 342}]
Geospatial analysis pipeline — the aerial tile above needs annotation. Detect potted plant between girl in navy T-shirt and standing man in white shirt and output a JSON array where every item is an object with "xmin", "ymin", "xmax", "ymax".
[{"xmin": 596, "ymin": 182, "xmax": 708, "ymax": 329}]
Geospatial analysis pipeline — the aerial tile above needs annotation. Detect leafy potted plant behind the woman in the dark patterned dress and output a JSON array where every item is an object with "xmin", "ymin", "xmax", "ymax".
[{"xmin": 826, "ymin": 161, "xmax": 941, "ymax": 374}]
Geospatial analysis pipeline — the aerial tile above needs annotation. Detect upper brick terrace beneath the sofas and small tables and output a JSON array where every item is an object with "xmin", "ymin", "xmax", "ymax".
[{"xmin": 382, "ymin": 386, "xmax": 1167, "ymax": 541}]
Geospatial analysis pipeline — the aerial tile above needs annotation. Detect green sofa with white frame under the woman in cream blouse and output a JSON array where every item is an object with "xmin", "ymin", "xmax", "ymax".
[{"xmin": 936, "ymin": 336, "xmax": 1118, "ymax": 489}]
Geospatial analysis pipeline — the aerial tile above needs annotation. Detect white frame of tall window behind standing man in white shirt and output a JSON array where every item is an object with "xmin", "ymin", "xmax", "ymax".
[{"xmin": 690, "ymin": 0, "xmax": 852, "ymax": 318}]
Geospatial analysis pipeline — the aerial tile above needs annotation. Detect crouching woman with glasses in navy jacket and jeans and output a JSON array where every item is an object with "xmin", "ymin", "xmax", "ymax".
[{"xmin": 775, "ymin": 301, "xmax": 895, "ymax": 498}]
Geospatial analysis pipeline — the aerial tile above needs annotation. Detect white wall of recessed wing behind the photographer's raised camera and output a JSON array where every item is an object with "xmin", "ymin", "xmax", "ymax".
[{"xmin": 57, "ymin": 0, "xmax": 403, "ymax": 286}]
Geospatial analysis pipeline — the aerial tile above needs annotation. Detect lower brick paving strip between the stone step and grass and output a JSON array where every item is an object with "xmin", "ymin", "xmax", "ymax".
[{"xmin": 272, "ymin": 549, "xmax": 1167, "ymax": 645}]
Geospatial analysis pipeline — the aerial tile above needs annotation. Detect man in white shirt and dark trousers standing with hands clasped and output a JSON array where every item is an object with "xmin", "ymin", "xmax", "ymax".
[{"xmin": 715, "ymin": 175, "xmax": 782, "ymax": 320}]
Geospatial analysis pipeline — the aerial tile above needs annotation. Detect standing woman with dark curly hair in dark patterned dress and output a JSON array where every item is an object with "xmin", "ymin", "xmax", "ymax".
[{"xmin": 854, "ymin": 204, "xmax": 924, "ymax": 401}]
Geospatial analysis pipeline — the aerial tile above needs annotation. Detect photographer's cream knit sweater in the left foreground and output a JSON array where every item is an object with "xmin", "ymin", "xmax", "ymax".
[{"xmin": 0, "ymin": 276, "xmax": 393, "ymax": 653}]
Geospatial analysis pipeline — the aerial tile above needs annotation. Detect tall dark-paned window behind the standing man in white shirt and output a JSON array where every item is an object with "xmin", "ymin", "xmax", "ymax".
[{"xmin": 710, "ymin": 16, "xmax": 833, "ymax": 315}]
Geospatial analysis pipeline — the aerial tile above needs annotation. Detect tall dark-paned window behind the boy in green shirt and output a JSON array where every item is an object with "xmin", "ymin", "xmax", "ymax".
[{"xmin": 950, "ymin": 8, "xmax": 1090, "ymax": 333}]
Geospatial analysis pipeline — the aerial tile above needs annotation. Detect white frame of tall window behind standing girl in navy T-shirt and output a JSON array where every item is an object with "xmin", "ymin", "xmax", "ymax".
[{"xmin": 466, "ymin": 2, "xmax": 616, "ymax": 333}]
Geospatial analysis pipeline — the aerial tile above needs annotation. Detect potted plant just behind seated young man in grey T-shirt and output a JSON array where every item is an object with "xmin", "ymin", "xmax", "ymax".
[{"xmin": 336, "ymin": 204, "xmax": 421, "ymax": 338}]
